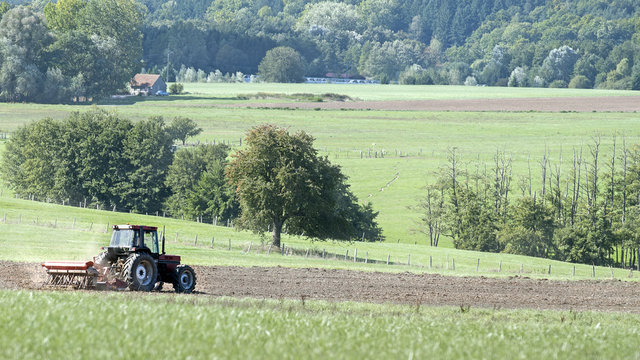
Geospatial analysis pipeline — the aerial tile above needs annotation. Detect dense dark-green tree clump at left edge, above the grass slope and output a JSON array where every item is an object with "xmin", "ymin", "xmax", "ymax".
[{"xmin": 2, "ymin": 110, "xmax": 173, "ymax": 212}]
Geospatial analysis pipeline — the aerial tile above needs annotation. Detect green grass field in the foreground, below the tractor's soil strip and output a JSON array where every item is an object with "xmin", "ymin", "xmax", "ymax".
[{"xmin": 0, "ymin": 291, "xmax": 640, "ymax": 359}]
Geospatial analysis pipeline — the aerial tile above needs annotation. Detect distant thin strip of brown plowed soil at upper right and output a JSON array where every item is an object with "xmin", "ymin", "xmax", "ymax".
[{"xmin": 232, "ymin": 96, "xmax": 640, "ymax": 112}]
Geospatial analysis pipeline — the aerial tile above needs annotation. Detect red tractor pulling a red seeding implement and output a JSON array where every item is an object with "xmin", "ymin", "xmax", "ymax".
[{"xmin": 42, "ymin": 225, "xmax": 196, "ymax": 293}]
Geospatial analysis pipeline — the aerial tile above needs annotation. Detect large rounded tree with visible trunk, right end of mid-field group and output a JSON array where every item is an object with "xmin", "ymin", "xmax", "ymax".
[{"xmin": 227, "ymin": 125, "xmax": 381, "ymax": 246}]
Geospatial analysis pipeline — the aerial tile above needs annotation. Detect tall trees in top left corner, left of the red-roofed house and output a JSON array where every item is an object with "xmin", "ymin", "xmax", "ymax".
[{"xmin": 0, "ymin": 0, "xmax": 144, "ymax": 103}]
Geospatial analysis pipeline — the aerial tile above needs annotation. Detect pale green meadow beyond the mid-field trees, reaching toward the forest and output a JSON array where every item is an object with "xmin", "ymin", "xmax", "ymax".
[{"xmin": 0, "ymin": 84, "xmax": 640, "ymax": 247}]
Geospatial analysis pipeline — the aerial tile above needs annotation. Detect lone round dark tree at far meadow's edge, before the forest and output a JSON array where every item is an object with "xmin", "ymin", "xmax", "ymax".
[{"xmin": 258, "ymin": 46, "xmax": 305, "ymax": 83}]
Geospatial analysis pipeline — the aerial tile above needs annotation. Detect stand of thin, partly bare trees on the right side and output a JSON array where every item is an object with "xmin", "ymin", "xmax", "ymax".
[{"xmin": 419, "ymin": 139, "xmax": 640, "ymax": 267}]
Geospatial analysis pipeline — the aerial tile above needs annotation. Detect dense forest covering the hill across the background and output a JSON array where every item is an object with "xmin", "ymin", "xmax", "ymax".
[{"xmin": 0, "ymin": 0, "xmax": 640, "ymax": 95}]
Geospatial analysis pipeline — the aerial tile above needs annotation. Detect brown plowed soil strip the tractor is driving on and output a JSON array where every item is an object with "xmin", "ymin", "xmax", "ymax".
[{"xmin": 5, "ymin": 262, "xmax": 640, "ymax": 313}]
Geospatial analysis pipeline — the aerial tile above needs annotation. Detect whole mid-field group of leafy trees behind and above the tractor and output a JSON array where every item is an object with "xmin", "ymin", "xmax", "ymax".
[{"xmin": 0, "ymin": 109, "xmax": 383, "ymax": 246}]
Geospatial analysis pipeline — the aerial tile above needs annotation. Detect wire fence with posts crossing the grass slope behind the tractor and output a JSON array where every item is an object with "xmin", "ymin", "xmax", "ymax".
[{"xmin": 0, "ymin": 212, "xmax": 634, "ymax": 279}]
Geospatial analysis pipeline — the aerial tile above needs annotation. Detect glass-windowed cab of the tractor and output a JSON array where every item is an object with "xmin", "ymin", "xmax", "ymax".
[{"xmin": 107, "ymin": 225, "xmax": 160, "ymax": 257}]
